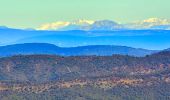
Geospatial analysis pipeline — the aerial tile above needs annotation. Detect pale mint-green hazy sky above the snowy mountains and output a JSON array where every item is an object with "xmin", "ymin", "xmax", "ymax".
[{"xmin": 0, "ymin": 0, "xmax": 170, "ymax": 28}]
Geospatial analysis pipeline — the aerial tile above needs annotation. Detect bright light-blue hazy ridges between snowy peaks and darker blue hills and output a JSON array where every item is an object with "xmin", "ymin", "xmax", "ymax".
[{"xmin": 0, "ymin": 27, "xmax": 170, "ymax": 50}]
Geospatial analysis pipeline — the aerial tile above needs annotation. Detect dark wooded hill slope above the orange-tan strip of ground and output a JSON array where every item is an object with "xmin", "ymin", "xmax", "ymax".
[{"xmin": 0, "ymin": 52, "xmax": 170, "ymax": 82}]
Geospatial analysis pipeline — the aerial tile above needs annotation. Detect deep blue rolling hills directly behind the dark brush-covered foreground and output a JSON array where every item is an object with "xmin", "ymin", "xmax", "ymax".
[{"xmin": 0, "ymin": 43, "xmax": 158, "ymax": 57}]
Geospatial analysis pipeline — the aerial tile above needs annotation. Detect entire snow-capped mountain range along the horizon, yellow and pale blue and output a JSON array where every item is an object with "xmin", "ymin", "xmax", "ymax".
[{"xmin": 37, "ymin": 18, "xmax": 170, "ymax": 31}]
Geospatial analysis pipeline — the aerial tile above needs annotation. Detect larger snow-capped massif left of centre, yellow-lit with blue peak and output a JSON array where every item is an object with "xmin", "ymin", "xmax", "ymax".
[{"xmin": 37, "ymin": 20, "xmax": 122, "ymax": 30}]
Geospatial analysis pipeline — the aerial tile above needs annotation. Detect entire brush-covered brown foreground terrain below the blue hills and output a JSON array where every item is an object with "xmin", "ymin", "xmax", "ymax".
[{"xmin": 0, "ymin": 51, "xmax": 170, "ymax": 100}]
